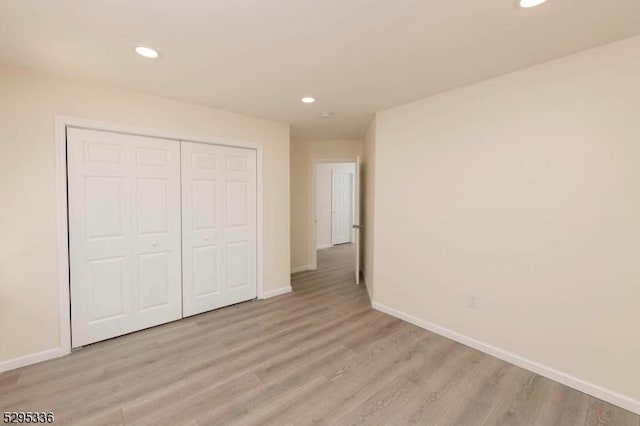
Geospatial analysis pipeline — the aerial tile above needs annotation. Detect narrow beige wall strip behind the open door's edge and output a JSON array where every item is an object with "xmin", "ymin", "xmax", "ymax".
[{"xmin": 360, "ymin": 119, "xmax": 376, "ymax": 298}]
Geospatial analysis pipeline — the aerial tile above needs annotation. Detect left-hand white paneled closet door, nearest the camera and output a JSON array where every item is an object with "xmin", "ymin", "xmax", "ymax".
[{"xmin": 67, "ymin": 128, "xmax": 182, "ymax": 347}]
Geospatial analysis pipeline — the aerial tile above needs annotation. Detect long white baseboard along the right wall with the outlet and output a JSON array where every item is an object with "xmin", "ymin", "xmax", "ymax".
[{"xmin": 371, "ymin": 302, "xmax": 640, "ymax": 414}]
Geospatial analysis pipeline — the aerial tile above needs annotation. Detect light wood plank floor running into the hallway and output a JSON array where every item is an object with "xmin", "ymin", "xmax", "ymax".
[{"xmin": 0, "ymin": 245, "xmax": 640, "ymax": 426}]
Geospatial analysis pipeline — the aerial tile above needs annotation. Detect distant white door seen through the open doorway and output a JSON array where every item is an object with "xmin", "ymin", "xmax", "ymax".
[{"xmin": 331, "ymin": 170, "xmax": 352, "ymax": 245}]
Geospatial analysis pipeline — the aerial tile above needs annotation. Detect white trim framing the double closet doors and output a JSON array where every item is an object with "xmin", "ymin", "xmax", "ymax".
[{"xmin": 55, "ymin": 116, "xmax": 265, "ymax": 356}]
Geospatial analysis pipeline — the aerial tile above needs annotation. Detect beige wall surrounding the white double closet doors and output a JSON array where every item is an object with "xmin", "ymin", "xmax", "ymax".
[{"xmin": 0, "ymin": 66, "xmax": 290, "ymax": 362}]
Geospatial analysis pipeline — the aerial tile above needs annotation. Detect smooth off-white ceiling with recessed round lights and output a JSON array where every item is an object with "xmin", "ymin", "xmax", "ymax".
[{"xmin": 0, "ymin": 0, "xmax": 640, "ymax": 139}]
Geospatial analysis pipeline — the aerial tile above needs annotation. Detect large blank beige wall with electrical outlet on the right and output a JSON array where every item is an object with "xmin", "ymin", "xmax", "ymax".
[{"xmin": 374, "ymin": 37, "xmax": 640, "ymax": 400}]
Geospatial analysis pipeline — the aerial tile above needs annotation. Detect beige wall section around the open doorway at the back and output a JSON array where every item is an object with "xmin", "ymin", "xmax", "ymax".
[{"xmin": 291, "ymin": 140, "xmax": 362, "ymax": 270}]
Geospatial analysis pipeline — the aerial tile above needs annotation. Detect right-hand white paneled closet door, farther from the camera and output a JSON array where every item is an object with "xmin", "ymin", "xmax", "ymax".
[{"xmin": 181, "ymin": 142, "xmax": 257, "ymax": 317}]
